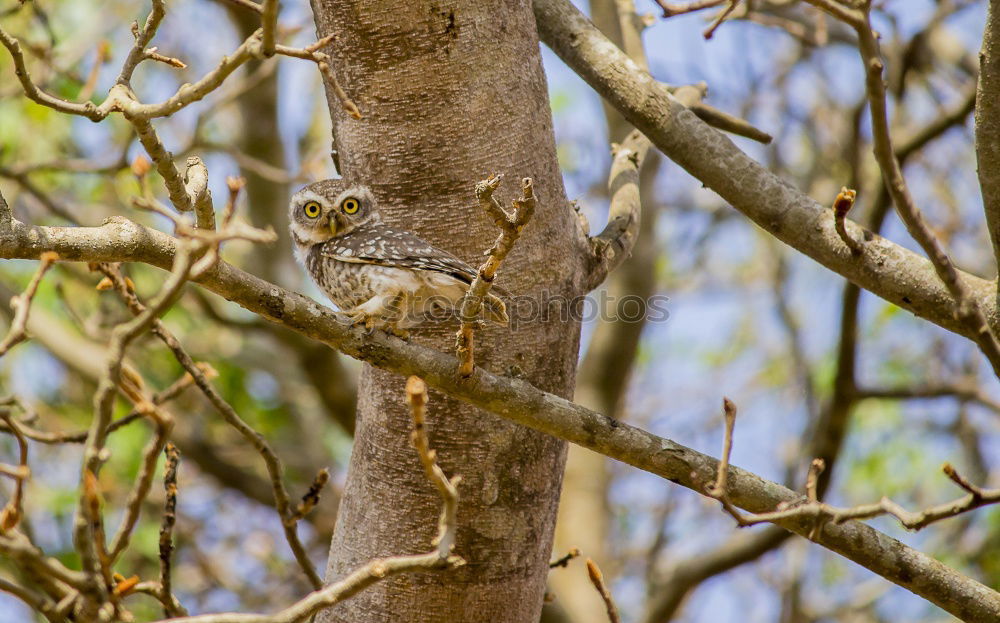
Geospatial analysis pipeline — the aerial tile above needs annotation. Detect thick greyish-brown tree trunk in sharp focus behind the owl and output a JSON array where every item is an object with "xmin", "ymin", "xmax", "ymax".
[{"xmin": 312, "ymin": 0, "xmax": 582, "ymax": 623}]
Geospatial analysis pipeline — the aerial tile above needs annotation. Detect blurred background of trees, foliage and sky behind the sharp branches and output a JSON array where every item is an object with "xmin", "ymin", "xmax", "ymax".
[{"xmin": 0, "ymin": 0, "xmax": 1000, "ymax": 623}]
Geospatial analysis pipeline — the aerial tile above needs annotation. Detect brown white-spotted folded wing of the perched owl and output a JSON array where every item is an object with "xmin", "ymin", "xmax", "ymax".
[{"xmin": 322, "ymin": 224, "xmax": 509, "ymax": 296}]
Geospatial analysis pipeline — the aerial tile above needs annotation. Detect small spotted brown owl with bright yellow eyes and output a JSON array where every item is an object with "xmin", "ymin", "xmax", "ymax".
[{"xmin": 288, "ymin": 180, "xmax": 508, "ymax": 337}]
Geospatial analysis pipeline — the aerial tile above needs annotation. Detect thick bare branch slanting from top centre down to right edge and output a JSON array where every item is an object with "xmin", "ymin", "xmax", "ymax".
[{"xmin": 534, "ymin": 0, "xmax": 996, "ymax": 346}]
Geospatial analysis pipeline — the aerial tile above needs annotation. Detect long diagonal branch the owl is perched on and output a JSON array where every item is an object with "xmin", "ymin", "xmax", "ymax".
[{"xmin": 0, "ymin": 218, "xmax": 1000, "ymax": 620}]
